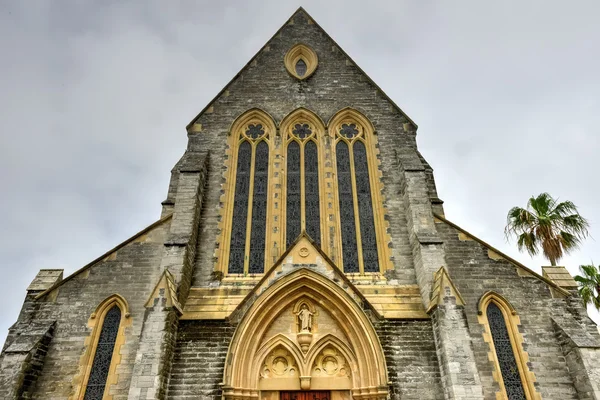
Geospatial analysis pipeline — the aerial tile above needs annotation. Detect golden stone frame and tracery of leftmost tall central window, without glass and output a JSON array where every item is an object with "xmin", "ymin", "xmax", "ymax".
[{"xmin": 215, "ymin": 108, "xmax": 277, "ymax": 275}]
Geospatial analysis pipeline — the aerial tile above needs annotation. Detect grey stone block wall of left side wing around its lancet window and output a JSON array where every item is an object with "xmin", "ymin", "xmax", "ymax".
[{"xmin": 19, "ymin": 223, "xmax": 169, "ymax": 400}]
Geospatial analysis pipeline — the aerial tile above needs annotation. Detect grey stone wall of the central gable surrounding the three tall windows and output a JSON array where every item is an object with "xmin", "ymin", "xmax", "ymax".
[{"xmin": 188, "ymin": 12, "xmax": 426, "ymax": 286}]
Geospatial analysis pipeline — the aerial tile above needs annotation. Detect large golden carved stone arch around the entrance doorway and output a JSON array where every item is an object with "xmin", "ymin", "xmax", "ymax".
[{"xmin": 223, "ymin": 269, "xmax": 388, "ymax": 400}]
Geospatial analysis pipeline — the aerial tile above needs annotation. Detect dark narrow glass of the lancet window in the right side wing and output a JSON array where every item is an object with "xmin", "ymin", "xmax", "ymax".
[{"xmin": 487, "ymin": 303, "xmax": 526, "ymax": 400}]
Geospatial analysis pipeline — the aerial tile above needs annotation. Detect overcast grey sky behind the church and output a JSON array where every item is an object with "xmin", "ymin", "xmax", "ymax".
[{"xmin": 0, "ymin": 0, "xmax": 600, "ymax": 342}]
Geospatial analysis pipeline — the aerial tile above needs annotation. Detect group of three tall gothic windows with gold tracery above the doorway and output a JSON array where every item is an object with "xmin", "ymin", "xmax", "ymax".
[{"xmin": 216, "ymin": 108, "xmax": 391, "ymax": 279}]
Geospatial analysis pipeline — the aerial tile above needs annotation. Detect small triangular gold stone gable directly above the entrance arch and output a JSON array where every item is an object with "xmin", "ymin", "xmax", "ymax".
[{"xmin": 230, "ymin": 231, "xmax": 383, "ymax": 319}]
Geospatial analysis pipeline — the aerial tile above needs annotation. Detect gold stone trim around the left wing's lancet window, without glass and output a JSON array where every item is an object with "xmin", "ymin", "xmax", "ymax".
[{"xmin": 69, "ymin": 294, "xmax": 132, "ymax": 400}]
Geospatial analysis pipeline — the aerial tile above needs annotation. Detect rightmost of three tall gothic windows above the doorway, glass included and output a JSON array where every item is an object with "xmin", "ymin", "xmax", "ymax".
[{"xmin": 329, "ymin": 109, "xmax": 387, "ymax": 274}]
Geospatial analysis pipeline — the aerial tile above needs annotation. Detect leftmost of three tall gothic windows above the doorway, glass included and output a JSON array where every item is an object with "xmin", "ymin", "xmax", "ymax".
[{"xmin": 221, "ymin": 109, "xmax": 276, "ymax": 274}]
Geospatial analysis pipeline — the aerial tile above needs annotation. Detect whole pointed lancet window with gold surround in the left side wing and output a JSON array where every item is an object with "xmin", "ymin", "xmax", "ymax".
[{"xmin": 76, "ymin": 295, "xmax": 131, "ymax": 400}]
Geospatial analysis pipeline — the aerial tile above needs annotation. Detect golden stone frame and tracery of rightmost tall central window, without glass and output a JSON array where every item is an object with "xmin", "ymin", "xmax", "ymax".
[{"xmin": 327, "ymin": 107, "xmax": 394, "ymax": 274}]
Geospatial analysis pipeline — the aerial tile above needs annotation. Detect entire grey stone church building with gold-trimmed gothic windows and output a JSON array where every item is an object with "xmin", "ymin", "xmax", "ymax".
[{"xmin": 0, "ymin": 9, "xmax": 600, "ymax": 400}]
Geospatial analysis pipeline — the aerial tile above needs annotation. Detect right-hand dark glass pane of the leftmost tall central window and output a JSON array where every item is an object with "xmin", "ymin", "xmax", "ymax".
[{"xmin": 248, "ymin": 141, "xmax": 269, "ymax": 274}]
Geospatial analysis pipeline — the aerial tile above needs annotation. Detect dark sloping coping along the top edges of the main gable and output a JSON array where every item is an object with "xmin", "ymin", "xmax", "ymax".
[{"xmin": 186, "ymin": 7, "xmax": 418, "ymax": 132}]
